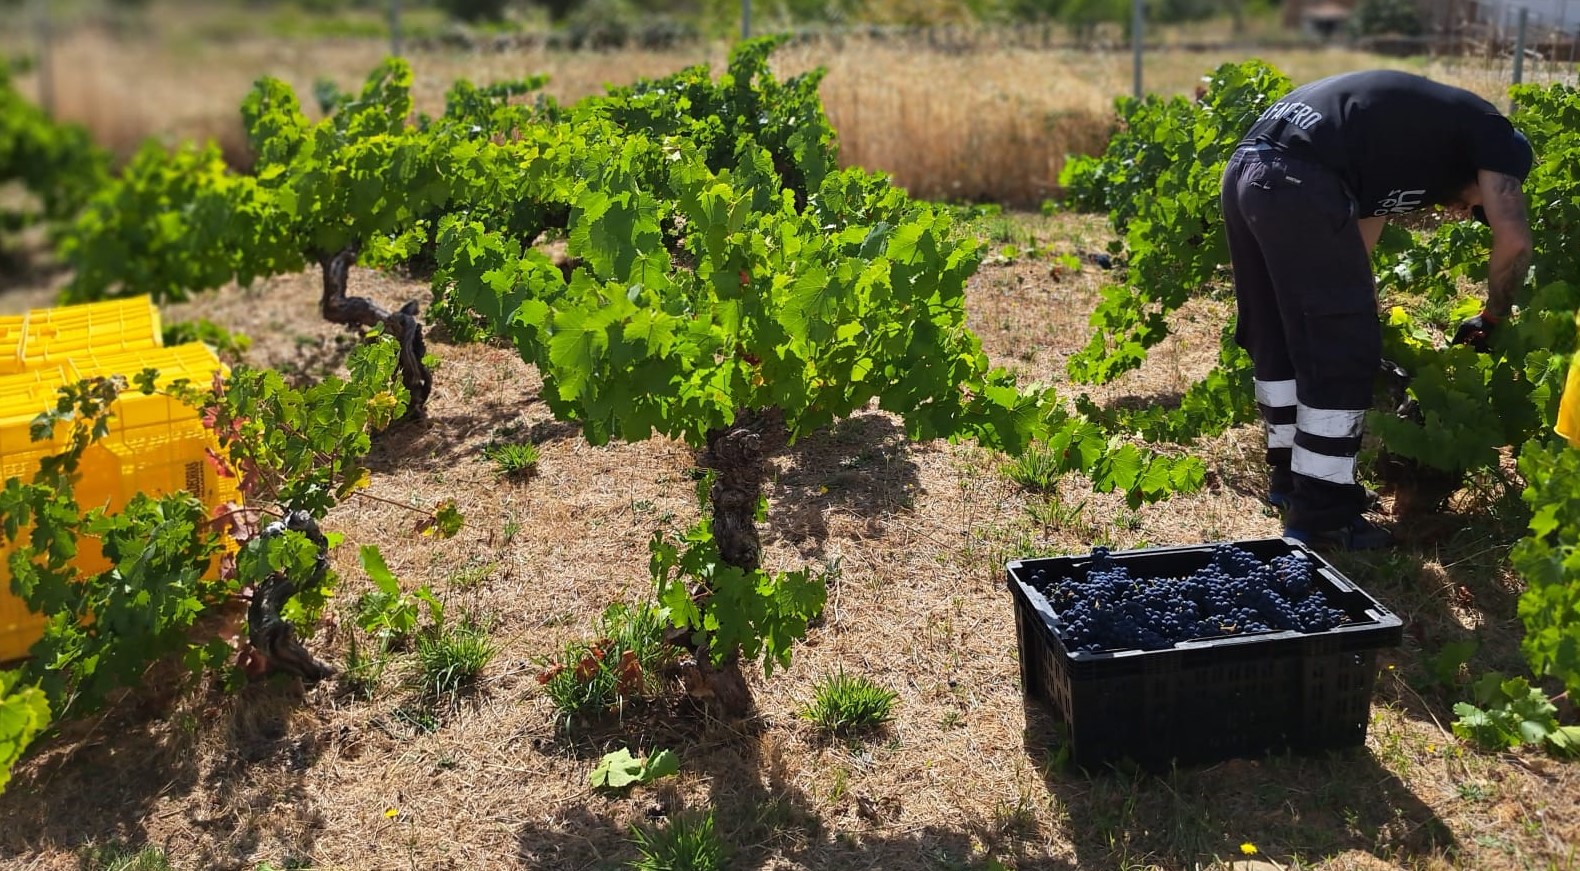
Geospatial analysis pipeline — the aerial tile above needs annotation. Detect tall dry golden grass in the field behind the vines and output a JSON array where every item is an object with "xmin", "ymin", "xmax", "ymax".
[{"xmin": 6, "ymin": 20, "xmax": 1564, "ymax": 207}]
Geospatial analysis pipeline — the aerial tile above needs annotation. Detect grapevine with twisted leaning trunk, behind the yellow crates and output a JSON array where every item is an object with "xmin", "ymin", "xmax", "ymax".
[{"xmin": 60, "ymin": 60, "xmax": 447, "ymax": 414}]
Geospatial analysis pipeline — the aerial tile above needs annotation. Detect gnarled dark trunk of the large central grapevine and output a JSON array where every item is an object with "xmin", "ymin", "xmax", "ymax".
[{"xmin": 683, "ymin": 408, "xmax": 788, "ymax": 718}]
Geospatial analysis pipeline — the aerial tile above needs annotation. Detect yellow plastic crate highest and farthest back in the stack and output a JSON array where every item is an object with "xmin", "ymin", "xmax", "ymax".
[{"xmin": 21, "ymin": 296, "xmax": 163, "ymax": 368}]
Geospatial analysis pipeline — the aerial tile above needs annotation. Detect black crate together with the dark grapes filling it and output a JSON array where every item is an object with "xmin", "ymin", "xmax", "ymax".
[{"xmin": 1006, "ymin": 539, "xmax": 1403, "ymax": 770}]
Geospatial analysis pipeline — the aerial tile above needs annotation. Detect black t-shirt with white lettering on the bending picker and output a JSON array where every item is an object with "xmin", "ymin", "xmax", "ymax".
[{"xmin": 1245, "ymin": 70, "xmax": 1531, "ymax": 217}]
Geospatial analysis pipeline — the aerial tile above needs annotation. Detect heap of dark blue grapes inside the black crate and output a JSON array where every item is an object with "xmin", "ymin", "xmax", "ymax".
[{"xmin": 1030, "ymin": 544, "xmax": 1346, "ymax": 651}]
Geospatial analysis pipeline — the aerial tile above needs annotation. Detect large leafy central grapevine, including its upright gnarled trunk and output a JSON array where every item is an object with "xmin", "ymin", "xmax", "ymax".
[{"xmin": 435, "ymin": 43, "xmax": 1202, "ymax": 710}]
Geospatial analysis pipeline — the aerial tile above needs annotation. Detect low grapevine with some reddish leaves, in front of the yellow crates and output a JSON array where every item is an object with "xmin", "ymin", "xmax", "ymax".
[{"xmin": 0, "ymin": 337, "xmax": 448, "ymax": 790}]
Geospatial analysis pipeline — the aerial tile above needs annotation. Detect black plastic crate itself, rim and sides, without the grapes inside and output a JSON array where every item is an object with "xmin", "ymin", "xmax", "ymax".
[{"xmin": 1005, "ymin": 539, "xmax": 1403, "ymax": 770}]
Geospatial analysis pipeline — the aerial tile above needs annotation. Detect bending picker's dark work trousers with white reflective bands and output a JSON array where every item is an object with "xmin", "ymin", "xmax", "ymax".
[{"xmin": 1223, "ymin": 145, "xmax": 1383, "ymax": 533}]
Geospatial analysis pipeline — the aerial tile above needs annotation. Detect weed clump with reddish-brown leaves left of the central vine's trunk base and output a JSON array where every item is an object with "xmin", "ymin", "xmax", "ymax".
[{"xmin": 537, "ymin": 602, "xmax": 672, "ymax": 726}]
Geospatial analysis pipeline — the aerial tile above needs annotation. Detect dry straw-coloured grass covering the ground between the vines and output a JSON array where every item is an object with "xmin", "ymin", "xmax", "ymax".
[{"xmin": 0, "ymin": 217, "xmax": 1580, "ymax": 871}]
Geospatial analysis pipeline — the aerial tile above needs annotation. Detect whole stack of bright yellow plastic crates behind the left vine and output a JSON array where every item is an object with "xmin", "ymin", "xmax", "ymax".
[{"xmin": 0, "ymin": 297, "xmax": 240, "ymax": 662}]
